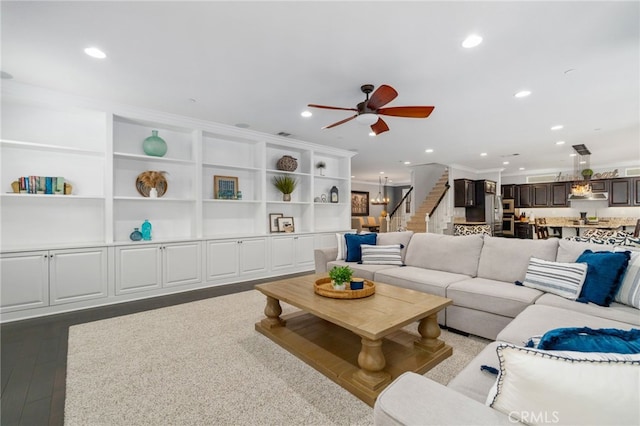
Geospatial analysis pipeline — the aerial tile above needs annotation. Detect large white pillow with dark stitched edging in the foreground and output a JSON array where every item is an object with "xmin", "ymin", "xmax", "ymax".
[{"xmin": 487, "ymin": 344, "xmax": 640, "ymax": 425}]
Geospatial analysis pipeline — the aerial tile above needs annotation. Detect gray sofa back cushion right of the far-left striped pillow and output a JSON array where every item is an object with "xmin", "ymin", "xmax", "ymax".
[{"xmin": 405, "ymin": 233, "xmax": 482, "ymax": 277}]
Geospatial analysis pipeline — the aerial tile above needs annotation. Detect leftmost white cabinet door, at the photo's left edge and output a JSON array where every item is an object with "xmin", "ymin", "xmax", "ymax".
[{"xmin": 0, "ymin": 251, "xmax": 49, "ymax": 312}]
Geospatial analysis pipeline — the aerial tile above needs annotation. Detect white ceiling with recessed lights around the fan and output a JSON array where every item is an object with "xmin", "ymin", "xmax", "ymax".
[{"xmin": 1, "ymin": 1, "xmax": 640, "ymax": 183}]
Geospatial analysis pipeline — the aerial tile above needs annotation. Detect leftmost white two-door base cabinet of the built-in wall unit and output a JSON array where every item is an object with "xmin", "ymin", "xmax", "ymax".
[{"xmin": 0, "ymin": 247, "xmax": 108, "ymax": 312}]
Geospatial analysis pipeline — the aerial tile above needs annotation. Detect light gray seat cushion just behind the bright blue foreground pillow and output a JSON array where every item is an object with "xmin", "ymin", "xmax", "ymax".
[{"xmin": 496, "ymin": 302, "xmax": 633, "ymax": 346}]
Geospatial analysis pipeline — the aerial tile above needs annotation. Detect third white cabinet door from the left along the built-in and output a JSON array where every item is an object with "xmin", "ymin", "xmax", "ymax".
[{"xmin": 116, "ymin": 244, "xmax": 162, "ymax": 294}]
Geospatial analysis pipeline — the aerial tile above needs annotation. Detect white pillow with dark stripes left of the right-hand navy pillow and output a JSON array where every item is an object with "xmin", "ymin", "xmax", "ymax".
[{"xmin": 522, "ymin": 257, "xmax": 588, "ymax": 300}]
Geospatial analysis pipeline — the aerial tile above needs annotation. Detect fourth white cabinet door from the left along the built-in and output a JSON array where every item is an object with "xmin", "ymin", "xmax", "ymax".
[{"xmin": 162, "ymin": 241, "xmax": 202, "ymax": 287}]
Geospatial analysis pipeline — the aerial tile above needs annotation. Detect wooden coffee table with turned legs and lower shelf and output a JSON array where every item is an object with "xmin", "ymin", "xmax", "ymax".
[{"xmin": 255, "ymin": 274, "xmax": 452, "ymax": 406}]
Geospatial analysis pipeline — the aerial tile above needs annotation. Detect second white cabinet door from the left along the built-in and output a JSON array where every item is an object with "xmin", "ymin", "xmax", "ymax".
[{"xmin": 49, "ymin": 247, "xmax": 108, "ymax": 305}]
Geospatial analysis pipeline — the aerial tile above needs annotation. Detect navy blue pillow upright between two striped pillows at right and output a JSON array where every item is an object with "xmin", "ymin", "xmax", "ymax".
[{"xmin": 576, "ymin": 250, "xmax": 630, "ymax": 306}]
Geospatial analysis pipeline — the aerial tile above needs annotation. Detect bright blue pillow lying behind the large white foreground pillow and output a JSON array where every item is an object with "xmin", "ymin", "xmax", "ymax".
[{"xmin": 537, "ymin": 327, "xmax": 640, "ymax": 354}]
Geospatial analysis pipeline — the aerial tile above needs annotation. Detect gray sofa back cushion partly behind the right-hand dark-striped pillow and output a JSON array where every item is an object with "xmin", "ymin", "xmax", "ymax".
[{"xmin": 478, "ymin": 236, "xmax": 558, "ymax": 283}]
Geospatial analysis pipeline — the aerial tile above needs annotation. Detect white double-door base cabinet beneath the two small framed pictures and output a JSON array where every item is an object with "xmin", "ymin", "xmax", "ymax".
[{"xmin": 271, "ymin": 235, "xmax": 314, "ymax": 271}]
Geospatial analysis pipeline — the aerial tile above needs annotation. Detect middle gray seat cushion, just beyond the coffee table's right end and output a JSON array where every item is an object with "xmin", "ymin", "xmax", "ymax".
[{"xmin": 447, "ymin": 278, "xmax": 542, "ymax": 318}]
